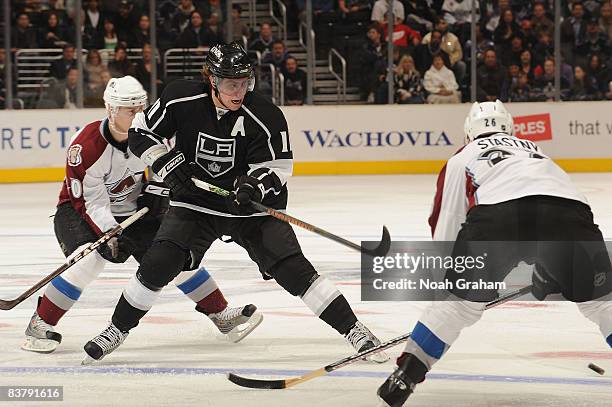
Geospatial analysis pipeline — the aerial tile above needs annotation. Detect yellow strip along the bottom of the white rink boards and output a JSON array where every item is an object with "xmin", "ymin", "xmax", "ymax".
[{"xmin": 0, "ymin": 158, "xmax": 612, "ymax": 183}]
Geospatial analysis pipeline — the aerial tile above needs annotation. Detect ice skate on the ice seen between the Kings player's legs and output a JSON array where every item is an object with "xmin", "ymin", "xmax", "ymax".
[{"xmin": 208, "ymin": 304, "xmax": 263, "ymax": 343}]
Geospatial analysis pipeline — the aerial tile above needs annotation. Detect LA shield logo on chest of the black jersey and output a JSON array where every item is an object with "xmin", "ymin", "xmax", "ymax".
[{"xmin": 195, "ymin": 132, "xmax": 236, "ymax": 178}]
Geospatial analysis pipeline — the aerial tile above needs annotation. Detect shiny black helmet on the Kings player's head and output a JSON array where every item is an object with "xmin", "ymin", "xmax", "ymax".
[{"xmin": 204, "ymin": 41, "xmax": 255, "ymax": 78}]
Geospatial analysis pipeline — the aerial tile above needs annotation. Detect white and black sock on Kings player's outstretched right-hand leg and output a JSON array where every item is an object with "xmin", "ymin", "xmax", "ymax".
[{"xmin": 302, "ymin": 276, "xmax": 357, "ymax": 335}]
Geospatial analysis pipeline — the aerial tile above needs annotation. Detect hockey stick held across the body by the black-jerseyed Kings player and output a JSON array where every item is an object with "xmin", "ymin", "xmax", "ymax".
[{"xmin": 191, "ymin": 178, "xmax": 391, "ymax": 257}]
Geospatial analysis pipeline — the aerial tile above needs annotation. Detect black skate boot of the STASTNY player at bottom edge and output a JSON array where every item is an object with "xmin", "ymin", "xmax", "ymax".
[{"xmin": 376, "ymin": 353, "xmax": 427, "ymax": 407}]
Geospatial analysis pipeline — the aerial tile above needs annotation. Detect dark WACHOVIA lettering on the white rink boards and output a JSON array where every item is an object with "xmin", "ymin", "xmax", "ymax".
[{"xmin": 302, "ymin": 129, "xmax": 453, "ymax": 148}]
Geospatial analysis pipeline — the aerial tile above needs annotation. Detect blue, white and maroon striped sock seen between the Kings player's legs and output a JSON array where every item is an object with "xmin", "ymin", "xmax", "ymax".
[{"xmin": 174, "ymin": 267, "xmax": 227, "ymax": 315}]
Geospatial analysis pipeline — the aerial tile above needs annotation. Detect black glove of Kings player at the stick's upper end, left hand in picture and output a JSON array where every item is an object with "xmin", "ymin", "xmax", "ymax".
[{"xmin": 151, "ymin": 151, "xmax": 199, "ymax": 196}]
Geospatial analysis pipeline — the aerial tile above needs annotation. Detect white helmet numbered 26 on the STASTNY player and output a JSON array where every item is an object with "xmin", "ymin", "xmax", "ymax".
[{"xmin": 463, "ymin": 99, "xmax": 514, "ymax": 144}]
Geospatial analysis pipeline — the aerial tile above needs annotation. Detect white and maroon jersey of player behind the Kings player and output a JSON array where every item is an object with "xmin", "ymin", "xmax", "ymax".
[{"xmin": 58, "ymin": 120, "xmax": 146, "ymax": 235}]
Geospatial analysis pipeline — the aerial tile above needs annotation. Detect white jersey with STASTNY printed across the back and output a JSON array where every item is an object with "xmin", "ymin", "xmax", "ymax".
[{"xmin": 429, "ymin": 133, "xmax": 588, "ymax": 241}]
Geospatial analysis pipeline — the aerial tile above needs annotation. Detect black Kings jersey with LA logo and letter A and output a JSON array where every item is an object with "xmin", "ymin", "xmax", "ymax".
[{"xmin": 129, "ymin": 80, "xmax": 293, "ymax": 216}]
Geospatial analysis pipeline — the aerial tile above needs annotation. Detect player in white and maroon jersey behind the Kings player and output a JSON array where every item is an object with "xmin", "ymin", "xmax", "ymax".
[{"xmin": 22, "ymin": 76, "xmax": 261, "ymax": 353}]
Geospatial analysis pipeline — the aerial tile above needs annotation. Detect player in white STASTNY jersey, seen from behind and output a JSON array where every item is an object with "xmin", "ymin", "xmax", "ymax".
[{"xmin": 378, "ymin": 100, "xmax": 612, "ymax": 407}]
